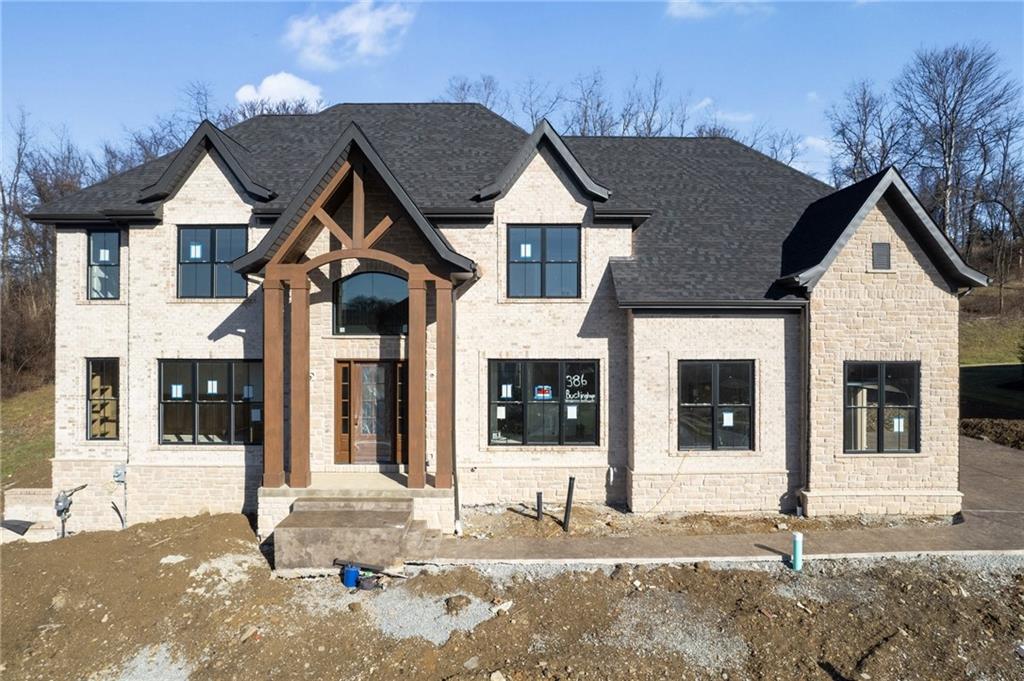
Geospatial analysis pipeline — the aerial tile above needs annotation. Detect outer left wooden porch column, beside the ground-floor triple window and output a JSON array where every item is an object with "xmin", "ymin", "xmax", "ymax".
[{"xmin": 263, "ymin": 279, "xmax": 285, "ymax": 487}]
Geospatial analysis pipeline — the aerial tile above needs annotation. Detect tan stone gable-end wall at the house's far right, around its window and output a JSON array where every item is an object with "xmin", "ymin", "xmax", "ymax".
[{"xmin": 804, "ymin": 201, "xmax": 961, "ymax": 515}]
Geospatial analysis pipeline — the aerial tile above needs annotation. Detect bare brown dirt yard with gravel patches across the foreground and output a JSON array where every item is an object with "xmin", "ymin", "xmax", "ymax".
[{"xmin": 6, "ymin": 515, "xmax": 1024, "ymax": 681}]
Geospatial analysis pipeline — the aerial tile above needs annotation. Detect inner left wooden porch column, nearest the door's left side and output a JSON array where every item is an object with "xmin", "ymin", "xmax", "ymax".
[{"xmin": 288, "ymin": 271, "xmax": 309, "ymax": 487}]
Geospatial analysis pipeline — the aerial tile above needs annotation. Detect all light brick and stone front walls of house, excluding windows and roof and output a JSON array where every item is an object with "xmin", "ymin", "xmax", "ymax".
[{"xmin": 46, "ymin": 143, "xmax": 959, "ymax": 534}]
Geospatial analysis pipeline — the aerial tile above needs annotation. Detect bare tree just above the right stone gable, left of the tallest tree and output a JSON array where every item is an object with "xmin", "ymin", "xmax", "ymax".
[{"xmin": 826, "ymin": 80, "xmax": 912, "ymax": 186}]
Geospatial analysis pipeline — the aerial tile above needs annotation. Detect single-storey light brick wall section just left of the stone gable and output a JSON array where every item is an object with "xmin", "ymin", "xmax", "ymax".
[{"xmin": 628, "ymin": 311, "xmax": 802, "ymax": 513}]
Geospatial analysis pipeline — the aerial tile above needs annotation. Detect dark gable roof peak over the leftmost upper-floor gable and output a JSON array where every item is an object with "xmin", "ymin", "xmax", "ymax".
[{"xmin": 138, "ymin": 119, "xmax": 278, "ymax": 204}]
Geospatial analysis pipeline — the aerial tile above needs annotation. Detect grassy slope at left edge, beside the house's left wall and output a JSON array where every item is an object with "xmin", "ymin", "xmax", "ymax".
[{"xmin": 0, "ymin": 385, "xmax": 53, "ymax": 487}]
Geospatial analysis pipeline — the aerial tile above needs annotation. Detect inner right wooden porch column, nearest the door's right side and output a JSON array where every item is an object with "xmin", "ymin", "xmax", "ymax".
[{"xmin": 407, "ymin": 273, "xmax": 427, "ymax": 490}]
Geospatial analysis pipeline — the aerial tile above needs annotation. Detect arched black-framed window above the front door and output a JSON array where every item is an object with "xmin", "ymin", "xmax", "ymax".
[{"xmin": 334, "ymin": 272, "xmax": 409, "ymax": 336}]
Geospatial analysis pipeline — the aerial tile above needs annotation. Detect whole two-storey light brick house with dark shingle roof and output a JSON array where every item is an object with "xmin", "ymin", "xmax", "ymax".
[{"xmin": 25, "ymin": 103, "xmax": 987, "ymax": 548}]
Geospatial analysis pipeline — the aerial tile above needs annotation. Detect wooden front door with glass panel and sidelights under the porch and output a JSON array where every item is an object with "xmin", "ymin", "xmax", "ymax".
[{"xmin": 334, "ymin": 360, "xmax": 406, "ymax": 464}]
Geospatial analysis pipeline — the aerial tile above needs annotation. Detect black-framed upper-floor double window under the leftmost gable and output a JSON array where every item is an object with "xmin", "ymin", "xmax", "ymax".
[{"xmin": 178, "ymin": 225, "xmax": 248, "ymax": 298}]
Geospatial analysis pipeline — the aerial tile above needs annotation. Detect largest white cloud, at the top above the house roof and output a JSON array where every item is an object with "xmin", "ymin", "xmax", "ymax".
[{"xmin": 284, "ymin": 0, "xmax": 415, "ymax": 71}]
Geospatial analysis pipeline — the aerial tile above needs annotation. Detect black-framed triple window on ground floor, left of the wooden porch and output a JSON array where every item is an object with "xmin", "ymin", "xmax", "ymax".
[{"xmin": 160, "ymin": 359, "xmax": 263, "ymax": 444}]
